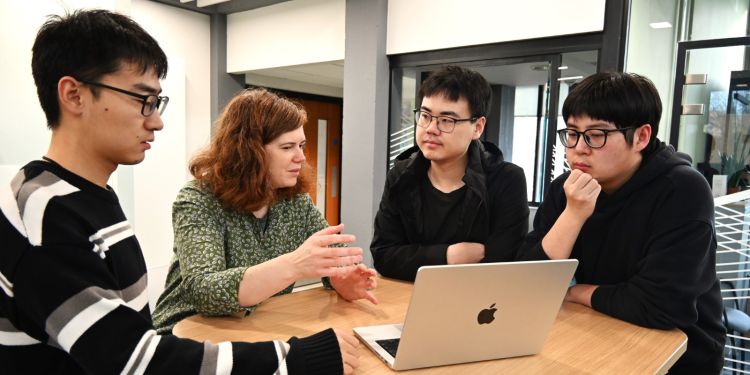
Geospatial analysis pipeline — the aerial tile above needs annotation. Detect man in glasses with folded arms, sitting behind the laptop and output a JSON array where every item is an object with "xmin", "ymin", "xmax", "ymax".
[{"xmin": 370, "ymin": 66, "xmax": 529, "ymax": 280}]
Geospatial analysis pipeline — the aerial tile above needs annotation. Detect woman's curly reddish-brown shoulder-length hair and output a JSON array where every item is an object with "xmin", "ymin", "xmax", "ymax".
[{"xmin": 190, "ymin": 88, "xmax": 309, "ymax": 213}]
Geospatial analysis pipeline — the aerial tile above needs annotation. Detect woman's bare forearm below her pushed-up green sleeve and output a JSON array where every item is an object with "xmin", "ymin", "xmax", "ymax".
[{"xmin": 238, "ymin": 254, "xmax": 299, "ymax": 306}]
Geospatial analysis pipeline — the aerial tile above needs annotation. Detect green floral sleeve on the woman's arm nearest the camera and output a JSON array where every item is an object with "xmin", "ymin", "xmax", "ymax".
[{"xmin": 172, "ymin": 186, "xmax": 247, "ymax": 316}]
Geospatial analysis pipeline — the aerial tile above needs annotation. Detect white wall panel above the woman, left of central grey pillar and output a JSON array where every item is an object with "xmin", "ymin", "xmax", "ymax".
[{"xmin": 227, "ymin": 0, "xmax": 346, "ymax": 73}]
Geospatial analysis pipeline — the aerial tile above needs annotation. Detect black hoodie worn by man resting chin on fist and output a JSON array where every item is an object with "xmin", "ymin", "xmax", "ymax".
[{"xmin": 518, "ymin": 142, "xmax": 726, "ymax": 374}]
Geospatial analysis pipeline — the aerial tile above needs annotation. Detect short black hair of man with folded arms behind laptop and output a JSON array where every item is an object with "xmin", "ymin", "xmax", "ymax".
[{"xmin": 419, "ymin": 65, "xmax": 492, "ymax": 117}]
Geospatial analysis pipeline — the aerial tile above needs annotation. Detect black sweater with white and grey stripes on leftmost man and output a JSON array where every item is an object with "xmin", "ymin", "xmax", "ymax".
[{"xmin": 0, "ymin": 161, "xmax": 342, "ymax": 374}]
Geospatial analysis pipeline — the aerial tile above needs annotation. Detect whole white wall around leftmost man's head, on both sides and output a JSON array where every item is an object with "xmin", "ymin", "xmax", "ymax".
[{"xmin": 0, "ymin": 0, "xmax": 211, "ymax": 310}]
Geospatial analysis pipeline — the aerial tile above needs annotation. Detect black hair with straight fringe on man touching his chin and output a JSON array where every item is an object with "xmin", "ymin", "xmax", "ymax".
[{"xmin": 562, "ymin": 72, "xmax": 662, "ymax": 149}]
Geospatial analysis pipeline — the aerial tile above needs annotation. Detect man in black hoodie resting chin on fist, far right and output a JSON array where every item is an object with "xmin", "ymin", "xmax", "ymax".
[{"xmin": 519, "ymin": 73, "xmax": 726, "ymax": 374}]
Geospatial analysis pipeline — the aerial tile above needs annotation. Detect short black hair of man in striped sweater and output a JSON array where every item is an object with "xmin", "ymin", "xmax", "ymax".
[{"xmin": 31, "ymin": 9, "xmax": 167, "ymax": 129}]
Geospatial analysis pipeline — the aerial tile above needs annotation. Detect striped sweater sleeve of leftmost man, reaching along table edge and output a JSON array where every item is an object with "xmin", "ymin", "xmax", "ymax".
[{"xmin": 13, "ymin": 235, "xmax": 342, "ymax": 374}]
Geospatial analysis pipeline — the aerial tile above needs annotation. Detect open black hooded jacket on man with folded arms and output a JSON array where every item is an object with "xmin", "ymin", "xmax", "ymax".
[{"xmin": 370, "ymin": 141, "xmax": 529, "ymax": 281}]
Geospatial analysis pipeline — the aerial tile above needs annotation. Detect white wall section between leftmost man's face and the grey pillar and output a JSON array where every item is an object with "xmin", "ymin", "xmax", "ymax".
[{"xmin": 130, "ymin": 0, "xmax": 211, "ymax": 307}]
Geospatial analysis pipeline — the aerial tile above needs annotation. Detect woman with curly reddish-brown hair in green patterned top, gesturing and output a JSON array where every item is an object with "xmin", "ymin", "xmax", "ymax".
[{"xmin": 153, "ymin": 89, "xmax": 378, "ymax": 333}]
